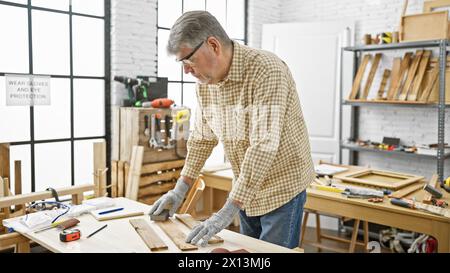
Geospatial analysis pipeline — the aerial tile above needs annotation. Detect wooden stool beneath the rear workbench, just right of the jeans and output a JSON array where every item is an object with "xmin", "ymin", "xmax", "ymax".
[{"xmin": 300, "ymin": 209, "xmax": 369, "ymax": 253}]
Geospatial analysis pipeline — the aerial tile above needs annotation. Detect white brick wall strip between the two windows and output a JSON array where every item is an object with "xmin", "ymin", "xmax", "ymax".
[{"xmin": 111, "ymin": 0, "xmax": 157, "ymax": 105}]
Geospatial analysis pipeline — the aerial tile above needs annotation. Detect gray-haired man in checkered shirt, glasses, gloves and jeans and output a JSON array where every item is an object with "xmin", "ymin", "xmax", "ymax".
[{"xmin": 150, "ymin": 11, "xmax": 314, "ymax": 248}]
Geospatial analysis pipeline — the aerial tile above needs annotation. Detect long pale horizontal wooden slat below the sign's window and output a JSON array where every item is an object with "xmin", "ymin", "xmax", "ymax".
[{"xmin": 0, "ymin": 184, "xmax": 94, "ymax": 208}]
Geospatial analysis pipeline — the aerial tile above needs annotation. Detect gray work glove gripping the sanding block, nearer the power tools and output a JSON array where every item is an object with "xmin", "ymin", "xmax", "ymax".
[{"xmin": 148, "ymin": 177, "xmax": 189, "ymax": 217}]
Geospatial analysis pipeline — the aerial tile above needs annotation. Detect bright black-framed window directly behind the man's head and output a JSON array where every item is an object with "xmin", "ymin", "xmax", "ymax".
[{"xmin": 158, "ymin": 0, "xmax": 247, "ymax": 164}]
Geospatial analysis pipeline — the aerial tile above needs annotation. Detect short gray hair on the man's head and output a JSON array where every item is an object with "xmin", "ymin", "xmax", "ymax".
[{"xmin": 167, "ymin": 10, "xmax": 232, "ymax": 55}]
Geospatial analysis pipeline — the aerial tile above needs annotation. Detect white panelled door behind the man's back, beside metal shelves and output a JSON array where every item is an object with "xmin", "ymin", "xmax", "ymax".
[{"xmin": 262, "ymin": 22, "xmax": 354, "ymax": 163}]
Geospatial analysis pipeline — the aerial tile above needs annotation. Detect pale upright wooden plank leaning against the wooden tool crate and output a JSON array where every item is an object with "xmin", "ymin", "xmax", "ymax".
[{"xmin": 125, "ymin": 146, "xmax": 144, "ymax": 200}]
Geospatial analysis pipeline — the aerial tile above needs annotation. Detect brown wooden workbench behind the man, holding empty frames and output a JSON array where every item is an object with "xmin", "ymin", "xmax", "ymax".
[{"xmin": 202, "ymin": 167, "xmax": 450, "ymax": 252}]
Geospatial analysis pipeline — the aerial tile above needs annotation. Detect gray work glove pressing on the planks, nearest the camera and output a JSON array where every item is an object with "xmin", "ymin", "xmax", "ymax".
[{"xmin": 186, "ymin": 199, "xmax": 240, "ymax": 246}]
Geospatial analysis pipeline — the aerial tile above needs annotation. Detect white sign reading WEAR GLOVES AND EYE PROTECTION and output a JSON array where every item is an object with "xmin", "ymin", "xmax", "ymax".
[{"xmin": 5, "ymin": 74, "xmax": 50, "ymax": 106}]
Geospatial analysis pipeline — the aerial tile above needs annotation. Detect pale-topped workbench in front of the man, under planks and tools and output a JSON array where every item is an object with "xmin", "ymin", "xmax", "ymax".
[{"xmin": 4, "ymin": 197, "xmax": 298, "ymax": 253}]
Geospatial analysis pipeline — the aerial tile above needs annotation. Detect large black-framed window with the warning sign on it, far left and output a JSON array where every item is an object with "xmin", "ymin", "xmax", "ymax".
[{"xmin": 0, "ymin": 0, "xmax": 110, "ymax": 193}]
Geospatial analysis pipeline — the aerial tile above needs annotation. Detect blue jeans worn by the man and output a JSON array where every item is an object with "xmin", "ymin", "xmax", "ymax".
[{"xmin": 239, "ymin": 191, "xmax": 306, "ymax": 248}]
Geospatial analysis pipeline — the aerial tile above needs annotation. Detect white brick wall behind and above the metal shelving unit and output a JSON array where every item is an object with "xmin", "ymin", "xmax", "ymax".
[{"xmin": 280, "ymin": 0, "xmax": 450, "ymax": 177}]
